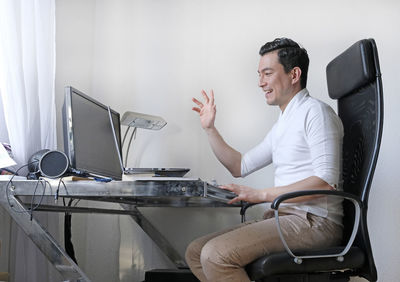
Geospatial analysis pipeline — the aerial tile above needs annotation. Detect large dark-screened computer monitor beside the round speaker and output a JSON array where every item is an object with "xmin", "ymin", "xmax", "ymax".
[{"xmin": 63, "ymin": 86, "xmax": 122, "ymax": 180}]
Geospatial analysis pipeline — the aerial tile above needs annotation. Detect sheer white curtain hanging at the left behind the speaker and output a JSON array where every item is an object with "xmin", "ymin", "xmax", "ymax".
[{"xmin": 0, "ymin": 0, "xmax": 58, "ymax": 282}]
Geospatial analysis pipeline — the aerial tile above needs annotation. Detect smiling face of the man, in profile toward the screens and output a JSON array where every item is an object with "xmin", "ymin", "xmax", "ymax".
[{"xmin": 258, "ymin": 51, "xmax": 295, "ymax": 111}]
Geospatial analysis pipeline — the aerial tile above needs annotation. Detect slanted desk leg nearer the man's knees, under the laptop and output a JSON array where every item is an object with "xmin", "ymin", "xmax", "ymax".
[{"xmin": 121, "ymin": 204, "xmax": 187, "ymax": 268}]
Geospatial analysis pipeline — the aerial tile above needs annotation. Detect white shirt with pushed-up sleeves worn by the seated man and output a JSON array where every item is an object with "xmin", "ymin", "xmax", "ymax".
[{"xmin": 241, "ymin": 88, "xmax": 343, "ymax": 224}]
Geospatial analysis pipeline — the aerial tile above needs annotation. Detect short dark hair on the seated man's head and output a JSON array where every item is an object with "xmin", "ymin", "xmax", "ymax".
[{"xmin": 259, "ymin": 37, "xmax": 310, "ymax": 88}]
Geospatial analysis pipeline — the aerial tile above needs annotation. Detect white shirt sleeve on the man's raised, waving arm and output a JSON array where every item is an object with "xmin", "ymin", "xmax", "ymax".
[{"xmin": 241, "ymin": 131, "xmax": 272, "ymax": 177}]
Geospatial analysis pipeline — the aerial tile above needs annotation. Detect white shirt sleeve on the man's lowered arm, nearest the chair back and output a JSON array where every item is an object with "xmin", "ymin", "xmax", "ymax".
[{"xmin": 305, "ymin": 105, "xmax": 343, "ymax": 186}]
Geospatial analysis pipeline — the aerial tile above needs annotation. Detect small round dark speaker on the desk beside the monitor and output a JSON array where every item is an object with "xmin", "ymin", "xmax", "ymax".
[{"xmin": 28, "ymin": 149, "xmax": 69, "ymax": 178}]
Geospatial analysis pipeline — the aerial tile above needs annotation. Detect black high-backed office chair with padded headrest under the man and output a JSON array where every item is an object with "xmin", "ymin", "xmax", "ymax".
[{"xmin": 244, "ymin": 39, "xmax": 383, "ymax": 282}]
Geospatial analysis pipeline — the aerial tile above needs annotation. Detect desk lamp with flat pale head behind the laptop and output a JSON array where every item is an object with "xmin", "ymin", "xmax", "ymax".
[{"xmin": 121, "ymin": 112, "xmax": 167, "ymax": 166}]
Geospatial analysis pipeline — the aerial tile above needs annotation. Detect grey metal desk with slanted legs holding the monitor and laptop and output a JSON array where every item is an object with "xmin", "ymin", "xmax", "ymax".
[{"xmin": 0, "ymin": 178, "xmax": 239, "ymax": 281}]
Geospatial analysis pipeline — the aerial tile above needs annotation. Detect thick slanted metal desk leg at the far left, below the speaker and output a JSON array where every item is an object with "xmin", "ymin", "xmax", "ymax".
[{"xmin": 0, "ymin": 187, "xmax": 90, "ymax": 282}]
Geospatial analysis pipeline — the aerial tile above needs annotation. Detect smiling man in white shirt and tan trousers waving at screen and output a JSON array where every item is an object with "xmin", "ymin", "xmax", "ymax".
[{"xmin": 186, "ymin": 38, "xmax": 343, "ymax": 282}]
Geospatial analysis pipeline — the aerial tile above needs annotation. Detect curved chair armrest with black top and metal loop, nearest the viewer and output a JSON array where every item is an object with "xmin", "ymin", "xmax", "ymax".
[{"xmin": 271, "ymin": 190, "xmax": 362, "ymax": 264}]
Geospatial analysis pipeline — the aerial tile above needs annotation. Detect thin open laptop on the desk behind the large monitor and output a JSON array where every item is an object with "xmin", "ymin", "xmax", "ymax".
[{"xmin": 107, "ymin": 106, "xmax": 190, "ymax": 177}]
